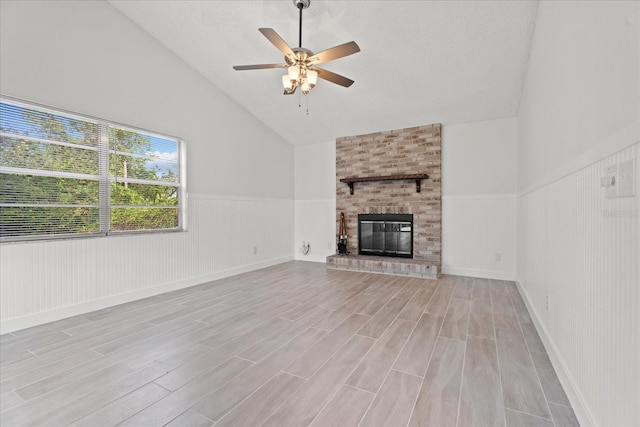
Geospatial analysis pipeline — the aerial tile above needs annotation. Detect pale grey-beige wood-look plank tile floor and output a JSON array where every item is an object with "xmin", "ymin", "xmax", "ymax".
[{"xmin": 0, "ymin": 262, "xmax": 578, "ymax": 427}]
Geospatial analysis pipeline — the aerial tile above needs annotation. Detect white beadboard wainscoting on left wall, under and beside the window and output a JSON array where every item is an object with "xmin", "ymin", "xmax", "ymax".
[{"xmin": 0, "ymin": 194, "xmax": 294, "ymax": 333}]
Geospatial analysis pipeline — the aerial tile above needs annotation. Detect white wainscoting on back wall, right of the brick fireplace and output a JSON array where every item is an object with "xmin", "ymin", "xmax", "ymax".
[{"xmin": 442, "ymin": 194, "xmax": 517, "ymax": 280}]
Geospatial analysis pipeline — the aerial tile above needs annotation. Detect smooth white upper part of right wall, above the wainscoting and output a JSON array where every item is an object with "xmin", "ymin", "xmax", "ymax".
[{"xmin": 518, "ymin": 1, "xmax": 640, "ymax": 191}]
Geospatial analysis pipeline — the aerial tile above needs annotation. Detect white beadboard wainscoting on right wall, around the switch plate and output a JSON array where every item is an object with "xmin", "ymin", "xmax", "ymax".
[{"xmin": 517, "ymin": 143, "xmax": 640, "ymax": 426}]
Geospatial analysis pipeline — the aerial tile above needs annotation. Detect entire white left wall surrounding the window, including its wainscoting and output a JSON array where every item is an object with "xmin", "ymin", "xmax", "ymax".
[{"xmin": 0, "ymin": 1, "xmax": 294, "ymax": 332}]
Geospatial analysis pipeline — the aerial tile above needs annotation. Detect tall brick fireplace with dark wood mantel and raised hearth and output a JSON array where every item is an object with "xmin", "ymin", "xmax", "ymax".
[{"xmin": 327, "ymin": 124, "xmax": 442, "ymax": 277}]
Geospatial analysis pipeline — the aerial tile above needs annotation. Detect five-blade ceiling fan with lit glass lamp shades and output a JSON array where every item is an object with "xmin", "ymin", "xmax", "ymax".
[{"xmin": 233, "ymin": 0, "xmax": 360, "ymax": 95}]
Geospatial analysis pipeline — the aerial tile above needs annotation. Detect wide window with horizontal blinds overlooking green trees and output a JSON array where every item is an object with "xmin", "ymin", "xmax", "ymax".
[{"xmin": 0, "ymin": 98, "xmax": 186, "ymax": 241}]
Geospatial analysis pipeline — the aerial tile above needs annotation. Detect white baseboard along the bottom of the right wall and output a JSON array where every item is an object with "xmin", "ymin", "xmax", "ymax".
[{"xmin": 515, "ymin": 278, "xmax": 598, "ymax": 427}]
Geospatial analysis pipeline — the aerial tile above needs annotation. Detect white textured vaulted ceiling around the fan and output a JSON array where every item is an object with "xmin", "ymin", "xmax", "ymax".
[{"xmin": 110, "ymin": 0, "xmax": 537, "ymax": 145}]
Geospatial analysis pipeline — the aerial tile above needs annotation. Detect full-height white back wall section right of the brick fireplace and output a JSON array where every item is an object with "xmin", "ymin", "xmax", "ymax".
[{"xmin": 442, "ymin": 118, "xmax": 518, "ymax": 280}]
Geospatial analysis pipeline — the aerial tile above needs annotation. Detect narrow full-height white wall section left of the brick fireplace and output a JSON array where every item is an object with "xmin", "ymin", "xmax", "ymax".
[{"xmin": 294, "ymin": 141, "xmax": 336, "ymax": 262}]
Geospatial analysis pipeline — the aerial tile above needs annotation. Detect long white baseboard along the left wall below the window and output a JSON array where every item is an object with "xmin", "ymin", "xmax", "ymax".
[{"xmin": 0, "ymin": 256, "xmax": 293, "ymax": 334}]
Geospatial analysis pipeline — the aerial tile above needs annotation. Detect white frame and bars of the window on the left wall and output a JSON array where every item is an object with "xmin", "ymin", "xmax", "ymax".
[{"xmin": 0, "ymin": 94, "xmax": 188, "ymax": 243}]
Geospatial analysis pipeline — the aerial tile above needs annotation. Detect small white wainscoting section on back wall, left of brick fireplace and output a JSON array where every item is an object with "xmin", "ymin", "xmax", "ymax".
[{"xmin": 294, "ymin": 198, "xmax": 336, "ymax": 263}]
